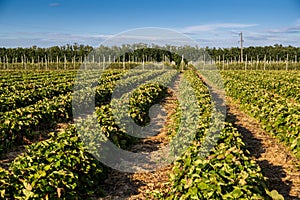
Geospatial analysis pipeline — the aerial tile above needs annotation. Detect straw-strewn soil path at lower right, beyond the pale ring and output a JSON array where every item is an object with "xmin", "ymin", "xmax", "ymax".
[{"xmin": 227, "ymin": 97, "xmax": 300, "ymax": 199}]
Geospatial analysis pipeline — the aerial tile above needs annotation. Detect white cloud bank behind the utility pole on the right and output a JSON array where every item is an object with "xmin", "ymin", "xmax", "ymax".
[{"xmin": 177, "ymin": 19, "xmax": 300, "ymax": 47}]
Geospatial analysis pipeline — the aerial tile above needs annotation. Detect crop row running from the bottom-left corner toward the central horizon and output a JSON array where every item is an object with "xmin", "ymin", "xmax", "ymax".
[{"xmin": 0, "ymin": 70, "xmax": 179, "ymax": 199}]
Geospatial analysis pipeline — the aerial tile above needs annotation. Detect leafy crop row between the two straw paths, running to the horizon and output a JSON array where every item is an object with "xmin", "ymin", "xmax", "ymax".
[{"xmin": 157, "ymin": 71, "xmax": 283, "ymax": 199}]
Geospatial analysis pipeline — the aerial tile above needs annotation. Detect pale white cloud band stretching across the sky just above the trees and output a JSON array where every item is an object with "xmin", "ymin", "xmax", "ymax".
[{"xmin": 0, "ymin": 19, "xmax": 300, "ymax": 47}]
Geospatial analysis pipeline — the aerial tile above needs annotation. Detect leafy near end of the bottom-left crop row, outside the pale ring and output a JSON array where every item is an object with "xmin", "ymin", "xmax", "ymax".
[{"xmin": 0, "ymin": 126, "xmax": 105, "ymax": 199}]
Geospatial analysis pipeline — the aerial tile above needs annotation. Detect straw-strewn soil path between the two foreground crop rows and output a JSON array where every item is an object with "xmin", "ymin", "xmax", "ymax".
[{"xmin": 100, "ymin": 75, "xmax": 181, "ymax": 200}]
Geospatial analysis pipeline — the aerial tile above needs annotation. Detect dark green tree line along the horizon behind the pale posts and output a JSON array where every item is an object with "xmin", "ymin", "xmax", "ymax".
[{"xmin": 0, "ymin": 43, "xmax": 300, "ymax": 63}]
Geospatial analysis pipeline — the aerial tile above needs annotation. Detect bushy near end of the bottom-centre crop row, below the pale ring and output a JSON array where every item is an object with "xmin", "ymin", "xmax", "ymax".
[{"xmin": 168, "ymin": 125, "xmax": 278, "ymax": 199}]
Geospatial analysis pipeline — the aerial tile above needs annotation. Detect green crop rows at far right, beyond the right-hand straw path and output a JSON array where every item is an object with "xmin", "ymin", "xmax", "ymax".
[{"xmin": 222, "ymin": 71, "xmax": 300, "ymax": 158}]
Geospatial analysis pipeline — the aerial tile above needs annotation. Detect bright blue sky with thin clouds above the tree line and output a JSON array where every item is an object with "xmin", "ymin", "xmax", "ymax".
[{"xmin": 0, "ymin": 0, "xmax": 300, "ymax": 47}]
